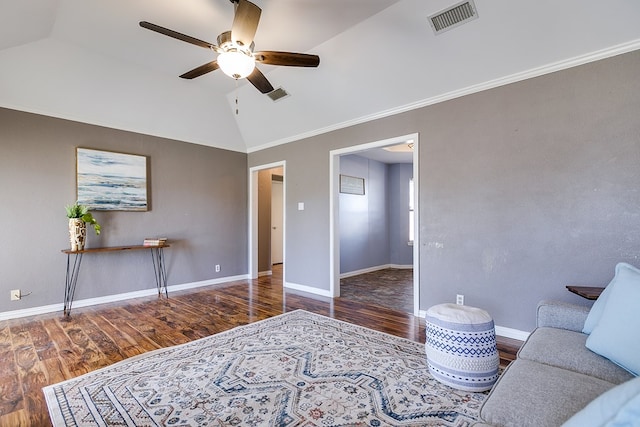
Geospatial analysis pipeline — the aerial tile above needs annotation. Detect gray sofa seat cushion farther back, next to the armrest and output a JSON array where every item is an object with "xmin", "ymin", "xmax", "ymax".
[{"xmin": 518, "ymin": 328, "xmax": 633, "ymax": 384}]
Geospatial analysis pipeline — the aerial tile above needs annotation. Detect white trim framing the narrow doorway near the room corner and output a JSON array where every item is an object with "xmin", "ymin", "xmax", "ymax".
[{"xmin": 249, "ymin": 160, "xmax": 287, "ymax": 283}]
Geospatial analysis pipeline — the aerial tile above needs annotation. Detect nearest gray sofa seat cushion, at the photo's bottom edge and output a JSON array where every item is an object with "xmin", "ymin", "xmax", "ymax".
[{"xmin": 480, "ymin": 359, "xmax": 614, "ymax": 427}]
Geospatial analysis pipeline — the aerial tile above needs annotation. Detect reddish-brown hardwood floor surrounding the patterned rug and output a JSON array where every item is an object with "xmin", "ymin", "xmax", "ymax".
[{"xmin": 0, "ymin": 268, "xmax": 519, "ymax": 426}]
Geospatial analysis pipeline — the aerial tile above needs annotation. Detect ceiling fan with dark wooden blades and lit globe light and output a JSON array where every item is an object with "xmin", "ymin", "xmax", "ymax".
[{"xmin": 140, "ymin": 0, "xmax": 320, "ymax": 93}]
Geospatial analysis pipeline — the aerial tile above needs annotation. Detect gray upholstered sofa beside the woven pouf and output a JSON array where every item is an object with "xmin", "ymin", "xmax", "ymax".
[{"xmin": 474, "ymin": 301, "xmax": 634, "ymax": 427}]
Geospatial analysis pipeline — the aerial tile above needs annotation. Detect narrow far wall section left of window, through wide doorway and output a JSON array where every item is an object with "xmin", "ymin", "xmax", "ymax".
[{"xmin": 388, "ymin": 163, "xmax": 413, "ymax": 266}]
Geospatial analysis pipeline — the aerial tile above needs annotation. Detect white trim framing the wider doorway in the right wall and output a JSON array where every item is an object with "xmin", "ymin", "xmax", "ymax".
[{"xmin": 329, "ymin": 133, "xmax": 420, "ymax": 316}]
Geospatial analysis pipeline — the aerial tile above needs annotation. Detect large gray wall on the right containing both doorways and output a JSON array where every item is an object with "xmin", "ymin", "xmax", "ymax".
[{"xmin": 249, "ymin": 51, "xmax": 640, "ymax": 330}]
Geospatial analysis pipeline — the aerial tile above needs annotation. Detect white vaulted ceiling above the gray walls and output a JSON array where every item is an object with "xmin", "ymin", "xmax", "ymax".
[{"xmin": 0, "ymin": 0, "xmax": 640, "ymax": 152}]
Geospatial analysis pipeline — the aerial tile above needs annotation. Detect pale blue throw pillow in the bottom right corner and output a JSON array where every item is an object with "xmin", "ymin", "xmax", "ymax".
[{"xmin": 562, "ymin": 377, "xmax": 640, "ymax": 427}]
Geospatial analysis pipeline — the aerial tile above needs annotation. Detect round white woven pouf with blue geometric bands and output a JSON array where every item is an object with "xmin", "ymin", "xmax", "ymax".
[{"xmin": 425, "ymin": 304, "xmax": 500, "ymax": 391}]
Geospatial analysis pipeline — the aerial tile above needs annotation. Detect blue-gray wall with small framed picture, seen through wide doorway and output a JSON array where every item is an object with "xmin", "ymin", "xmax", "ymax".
[{"xmin": 339, "ymin": 155, "xmax": 389, "ymax": 273}]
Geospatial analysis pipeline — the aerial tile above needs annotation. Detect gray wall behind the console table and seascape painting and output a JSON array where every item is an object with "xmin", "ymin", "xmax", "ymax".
[{"xmin": 0, "ymin": 109, "xmax": 248, "ymax": 312}]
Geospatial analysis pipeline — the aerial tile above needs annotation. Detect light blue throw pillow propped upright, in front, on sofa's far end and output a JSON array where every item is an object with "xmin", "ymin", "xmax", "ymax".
[{"xmin": 586, "ymin": 264, "xmax": 640, "ymax": 375}]
